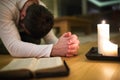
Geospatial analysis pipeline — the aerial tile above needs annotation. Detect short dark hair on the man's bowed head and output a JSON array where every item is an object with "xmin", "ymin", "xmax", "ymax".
[{"xmin": 20, "ymin": 0, "xmax": 54, "ymax": 38}]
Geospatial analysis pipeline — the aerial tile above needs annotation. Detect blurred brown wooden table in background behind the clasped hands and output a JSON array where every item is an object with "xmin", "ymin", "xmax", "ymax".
[{"xmin": 54, "ymin": 16, "xmax": 92, "ymax": 34}]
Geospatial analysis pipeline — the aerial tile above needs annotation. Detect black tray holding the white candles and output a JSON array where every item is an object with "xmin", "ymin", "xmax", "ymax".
[{"xmin": 85, "ymin": 47, "xmax": 120, "ymax": 61}]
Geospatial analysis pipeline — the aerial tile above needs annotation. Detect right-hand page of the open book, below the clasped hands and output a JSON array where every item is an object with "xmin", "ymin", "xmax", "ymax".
[{"xmin": 34, "ymin": 57, "xmax": 64, "ymax": 70}]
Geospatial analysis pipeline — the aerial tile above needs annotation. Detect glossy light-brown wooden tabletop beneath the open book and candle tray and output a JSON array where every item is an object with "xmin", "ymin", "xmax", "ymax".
[{"xmin": 0, "ymin": 35, "xmax": 120, "ymax": 80}]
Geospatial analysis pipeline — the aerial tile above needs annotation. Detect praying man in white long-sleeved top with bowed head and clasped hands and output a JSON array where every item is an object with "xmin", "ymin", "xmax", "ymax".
[{"xmin": 0, "ymin": 0, "xmax": 79, "ymax": 57}]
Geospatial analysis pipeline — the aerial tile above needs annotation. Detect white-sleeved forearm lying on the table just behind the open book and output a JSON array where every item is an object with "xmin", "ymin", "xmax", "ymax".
[{"xmin": 1, "ymin": 37, "xmax": 52, "ymax": 57}]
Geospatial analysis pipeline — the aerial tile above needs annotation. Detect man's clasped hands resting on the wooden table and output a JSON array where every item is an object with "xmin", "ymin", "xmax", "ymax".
[{"xmin": 51, "ymin": 32, "xmax": 80, "ymax": 57}]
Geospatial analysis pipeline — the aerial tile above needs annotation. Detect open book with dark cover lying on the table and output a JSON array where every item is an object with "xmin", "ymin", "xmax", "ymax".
[{"xmin": 0, "ymin": 57, "xmax": 69, "ymax": 79}]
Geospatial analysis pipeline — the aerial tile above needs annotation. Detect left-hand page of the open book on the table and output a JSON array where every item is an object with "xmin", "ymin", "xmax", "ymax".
[{"xmin": 0, "ymin": 58, "xmax": 37, "ymax": 71}]
